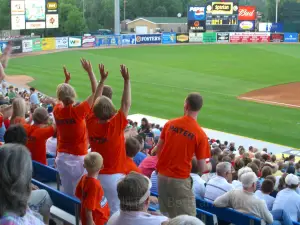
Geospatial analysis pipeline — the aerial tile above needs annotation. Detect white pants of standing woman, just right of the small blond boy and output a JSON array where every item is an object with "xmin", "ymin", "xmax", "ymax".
[{"xmin": 98, "ymin": 173, "xmax": 125, "ymax": 216}]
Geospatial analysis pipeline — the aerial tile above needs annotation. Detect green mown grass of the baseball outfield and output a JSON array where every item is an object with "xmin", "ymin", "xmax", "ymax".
[{"xmin": 7, "ymin": 44, "xmax": 300, "ymax": 148}]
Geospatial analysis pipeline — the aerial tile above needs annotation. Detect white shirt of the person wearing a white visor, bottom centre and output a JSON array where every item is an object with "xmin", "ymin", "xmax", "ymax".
[{"xmin": 107, "ymin": 210, "xmax": 169, "ymax": 225}]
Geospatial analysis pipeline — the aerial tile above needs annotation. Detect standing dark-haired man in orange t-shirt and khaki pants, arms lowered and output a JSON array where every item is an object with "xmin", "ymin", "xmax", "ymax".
[{"xmin": 155, "ymin": 93, "xmax": 210, "ymax": 218}]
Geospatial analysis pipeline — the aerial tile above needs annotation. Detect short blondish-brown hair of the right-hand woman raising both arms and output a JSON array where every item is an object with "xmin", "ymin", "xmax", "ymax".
[{"xmin": 93, "ymin": 96, "xmax": 116, "ymax": 121}]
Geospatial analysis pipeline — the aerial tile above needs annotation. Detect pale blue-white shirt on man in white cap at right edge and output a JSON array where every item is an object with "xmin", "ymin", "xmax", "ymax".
[{"xmin": 273, "ymin": 188, "xmax": 300, "ymax": 221}]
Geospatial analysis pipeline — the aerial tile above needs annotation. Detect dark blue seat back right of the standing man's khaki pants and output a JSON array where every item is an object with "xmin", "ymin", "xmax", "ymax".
[{"xmin": 196, "ymin": 199, "xmax": 266, "ymax": 225}]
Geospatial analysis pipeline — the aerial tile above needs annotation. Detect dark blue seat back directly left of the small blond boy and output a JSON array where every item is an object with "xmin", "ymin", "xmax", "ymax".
[{"xmin": 32, "ymin": 179, "xmax": 80, "ymax": 224}]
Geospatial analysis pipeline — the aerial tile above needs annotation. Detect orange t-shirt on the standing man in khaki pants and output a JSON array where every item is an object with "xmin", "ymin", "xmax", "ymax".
[{"xmin": 157, "ymin": 116, "xmax": 210, "ymax": 179}]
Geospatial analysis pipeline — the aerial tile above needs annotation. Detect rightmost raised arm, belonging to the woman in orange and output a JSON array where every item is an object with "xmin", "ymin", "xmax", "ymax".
[{"xmin": 120, "ymin": 65, "xmax": 131, "ymax": 117}]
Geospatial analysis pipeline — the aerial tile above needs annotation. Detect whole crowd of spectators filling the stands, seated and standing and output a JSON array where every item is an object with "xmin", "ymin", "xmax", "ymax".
[{"xmin": 0, "ymin": 42, "xmax": 300, "ymax": 225}]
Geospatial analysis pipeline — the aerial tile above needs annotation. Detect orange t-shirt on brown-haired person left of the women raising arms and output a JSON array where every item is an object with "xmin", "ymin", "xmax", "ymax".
[{"xmin": 23, "ymin": 124, "xmax": 54, "ymax": 165}]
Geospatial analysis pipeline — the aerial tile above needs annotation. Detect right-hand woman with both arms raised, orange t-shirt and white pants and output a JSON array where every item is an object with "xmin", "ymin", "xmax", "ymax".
[{"xmin": 86, "ymin": 65, "xmax": 131, "ymax": 214}]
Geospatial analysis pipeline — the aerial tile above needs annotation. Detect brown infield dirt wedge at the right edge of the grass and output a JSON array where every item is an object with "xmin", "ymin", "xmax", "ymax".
[{"xmin": 238, "ymin": 82, "xmax": 300, "ymax": 108}]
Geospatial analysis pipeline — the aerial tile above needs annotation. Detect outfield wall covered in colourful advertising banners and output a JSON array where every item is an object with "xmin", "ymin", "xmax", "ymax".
[{"xmin": 0, "ymin": 32, "xmax": 300, "ymax": 54}]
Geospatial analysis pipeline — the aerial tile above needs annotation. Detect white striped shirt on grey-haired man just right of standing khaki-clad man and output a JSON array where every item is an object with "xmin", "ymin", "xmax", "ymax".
[{"xmin": 204, "ymin": 175, "xmax": 233, "ymax": 202}]
